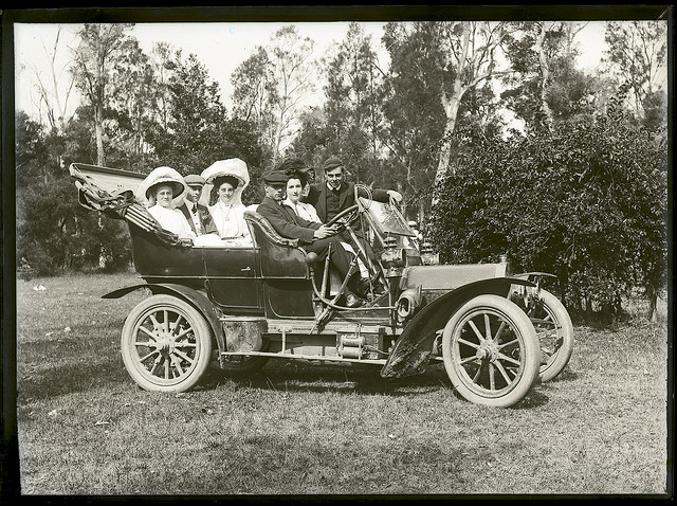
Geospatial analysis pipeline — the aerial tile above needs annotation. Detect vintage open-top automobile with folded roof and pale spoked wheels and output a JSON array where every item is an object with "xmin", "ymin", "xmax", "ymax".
[{"xmin": 70, "ymin": 163, "xmax": 573, "ymax": 407}]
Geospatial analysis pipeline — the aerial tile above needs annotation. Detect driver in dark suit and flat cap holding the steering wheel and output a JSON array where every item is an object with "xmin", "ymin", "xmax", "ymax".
[{"xmin": 256, "ymin": 170, "xmax": 364, "ymax": 307}]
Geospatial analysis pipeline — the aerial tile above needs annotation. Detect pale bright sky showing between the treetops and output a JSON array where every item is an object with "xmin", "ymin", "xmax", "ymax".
[{"xmin": 14, "ymin": 21, "xmax": 605, "ymax": 125}]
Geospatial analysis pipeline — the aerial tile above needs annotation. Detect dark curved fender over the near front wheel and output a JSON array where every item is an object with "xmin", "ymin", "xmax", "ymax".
[{"xmin": 381, "ymin": 277, "xmax": 535, "ymax": 378}]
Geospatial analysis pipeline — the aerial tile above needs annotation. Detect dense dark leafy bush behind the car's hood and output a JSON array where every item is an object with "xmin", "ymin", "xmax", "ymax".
[{"xmin": 431, "ymin": 105, "xmax": 667, "ymax": 313}]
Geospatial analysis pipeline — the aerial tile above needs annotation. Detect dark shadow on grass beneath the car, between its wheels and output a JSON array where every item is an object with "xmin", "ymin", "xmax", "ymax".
[{"xmin": 201, "ymin": 361, "xmax": 451, "ymax": 396}]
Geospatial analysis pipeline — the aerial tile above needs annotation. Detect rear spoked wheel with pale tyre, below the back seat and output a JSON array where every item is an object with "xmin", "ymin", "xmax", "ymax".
[{"xmin": 121, "ymin": 295, "xmax": 212, "ymax": 392}]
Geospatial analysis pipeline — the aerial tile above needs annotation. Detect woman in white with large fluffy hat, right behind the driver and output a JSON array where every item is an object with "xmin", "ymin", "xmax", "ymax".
[{"xmin": 202, "ymin": 158, "xmax": 253, "ymax": 246}]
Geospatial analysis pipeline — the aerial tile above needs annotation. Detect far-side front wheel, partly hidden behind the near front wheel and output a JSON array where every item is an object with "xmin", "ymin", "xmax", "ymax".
[{"xmin": 527, "ymin": 290, "xmax": 574, "ymax": 381}]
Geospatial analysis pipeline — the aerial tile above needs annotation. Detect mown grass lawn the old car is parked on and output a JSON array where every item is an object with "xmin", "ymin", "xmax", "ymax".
[{"xmin": 17, "ymin": 274, "xmax": 668, "ymax": 495}]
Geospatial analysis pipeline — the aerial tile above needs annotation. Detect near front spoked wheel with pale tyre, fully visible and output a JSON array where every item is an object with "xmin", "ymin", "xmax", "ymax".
[{"xmin": 442, "ymin": 295, "xmax": 541, "ymax": 407}]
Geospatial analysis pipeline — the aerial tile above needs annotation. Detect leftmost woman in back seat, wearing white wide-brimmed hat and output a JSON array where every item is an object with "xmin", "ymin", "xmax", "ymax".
[{"xmin": 138, "ymin": 167, "xmax": 195, "ymax": 239}]
